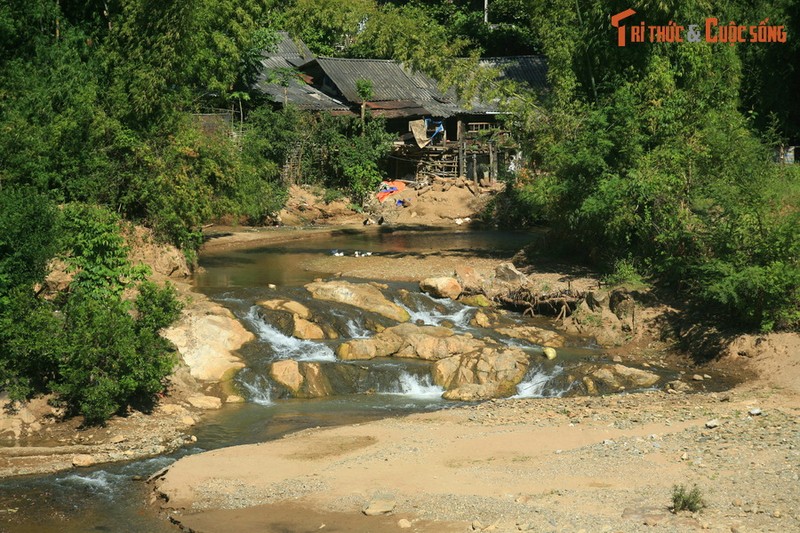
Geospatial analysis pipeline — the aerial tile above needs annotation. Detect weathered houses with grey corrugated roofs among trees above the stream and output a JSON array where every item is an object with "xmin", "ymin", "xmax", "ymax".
[{"xmin": 253, "ymin": 33, "xmax": 547, "ymax": 181}]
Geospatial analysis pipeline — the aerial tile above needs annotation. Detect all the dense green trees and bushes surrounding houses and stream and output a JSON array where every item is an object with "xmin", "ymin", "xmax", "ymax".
[{"xmin": 0, "ymin": 0, "xmax": 800, "ymax": 422}]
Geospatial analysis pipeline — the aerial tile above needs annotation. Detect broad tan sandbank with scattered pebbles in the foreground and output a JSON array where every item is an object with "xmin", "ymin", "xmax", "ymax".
[{"xmin": 158, "ymin": 376, "xmax": 800, "ymax": 532}]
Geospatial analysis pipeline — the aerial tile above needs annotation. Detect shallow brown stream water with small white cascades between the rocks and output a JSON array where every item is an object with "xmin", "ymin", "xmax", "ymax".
[{"xmin": 0, "ymin": 227, "xmax": 620, "ymax": 533}]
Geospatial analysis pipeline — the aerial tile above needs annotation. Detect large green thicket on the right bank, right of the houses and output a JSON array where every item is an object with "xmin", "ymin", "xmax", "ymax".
[{"xmin": 494, "ymin": 1, "xmax": 800, "ymax": 330}]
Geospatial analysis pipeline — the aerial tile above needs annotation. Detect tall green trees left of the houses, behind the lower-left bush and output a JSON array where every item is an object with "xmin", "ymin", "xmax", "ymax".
[{"xmin": 0, "ymin": 0, "xmax": 288, "ymax": 256}]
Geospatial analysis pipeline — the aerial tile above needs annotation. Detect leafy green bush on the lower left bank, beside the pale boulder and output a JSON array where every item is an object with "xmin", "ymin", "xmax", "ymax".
[{"xmin": 0, "ymin": 195, "xmax": 180, "ymax": 424}]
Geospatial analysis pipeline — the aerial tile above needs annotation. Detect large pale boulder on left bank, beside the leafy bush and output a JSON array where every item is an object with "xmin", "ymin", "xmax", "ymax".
[{"xmin": 163, "ymin": 295, "xmax": 250, "ymax": 381}]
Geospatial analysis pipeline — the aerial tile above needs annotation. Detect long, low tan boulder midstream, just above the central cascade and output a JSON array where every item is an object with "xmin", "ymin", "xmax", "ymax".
[{"xmin": 336, "ymin": 323, "xmax": 486, "ymax": 361}]
